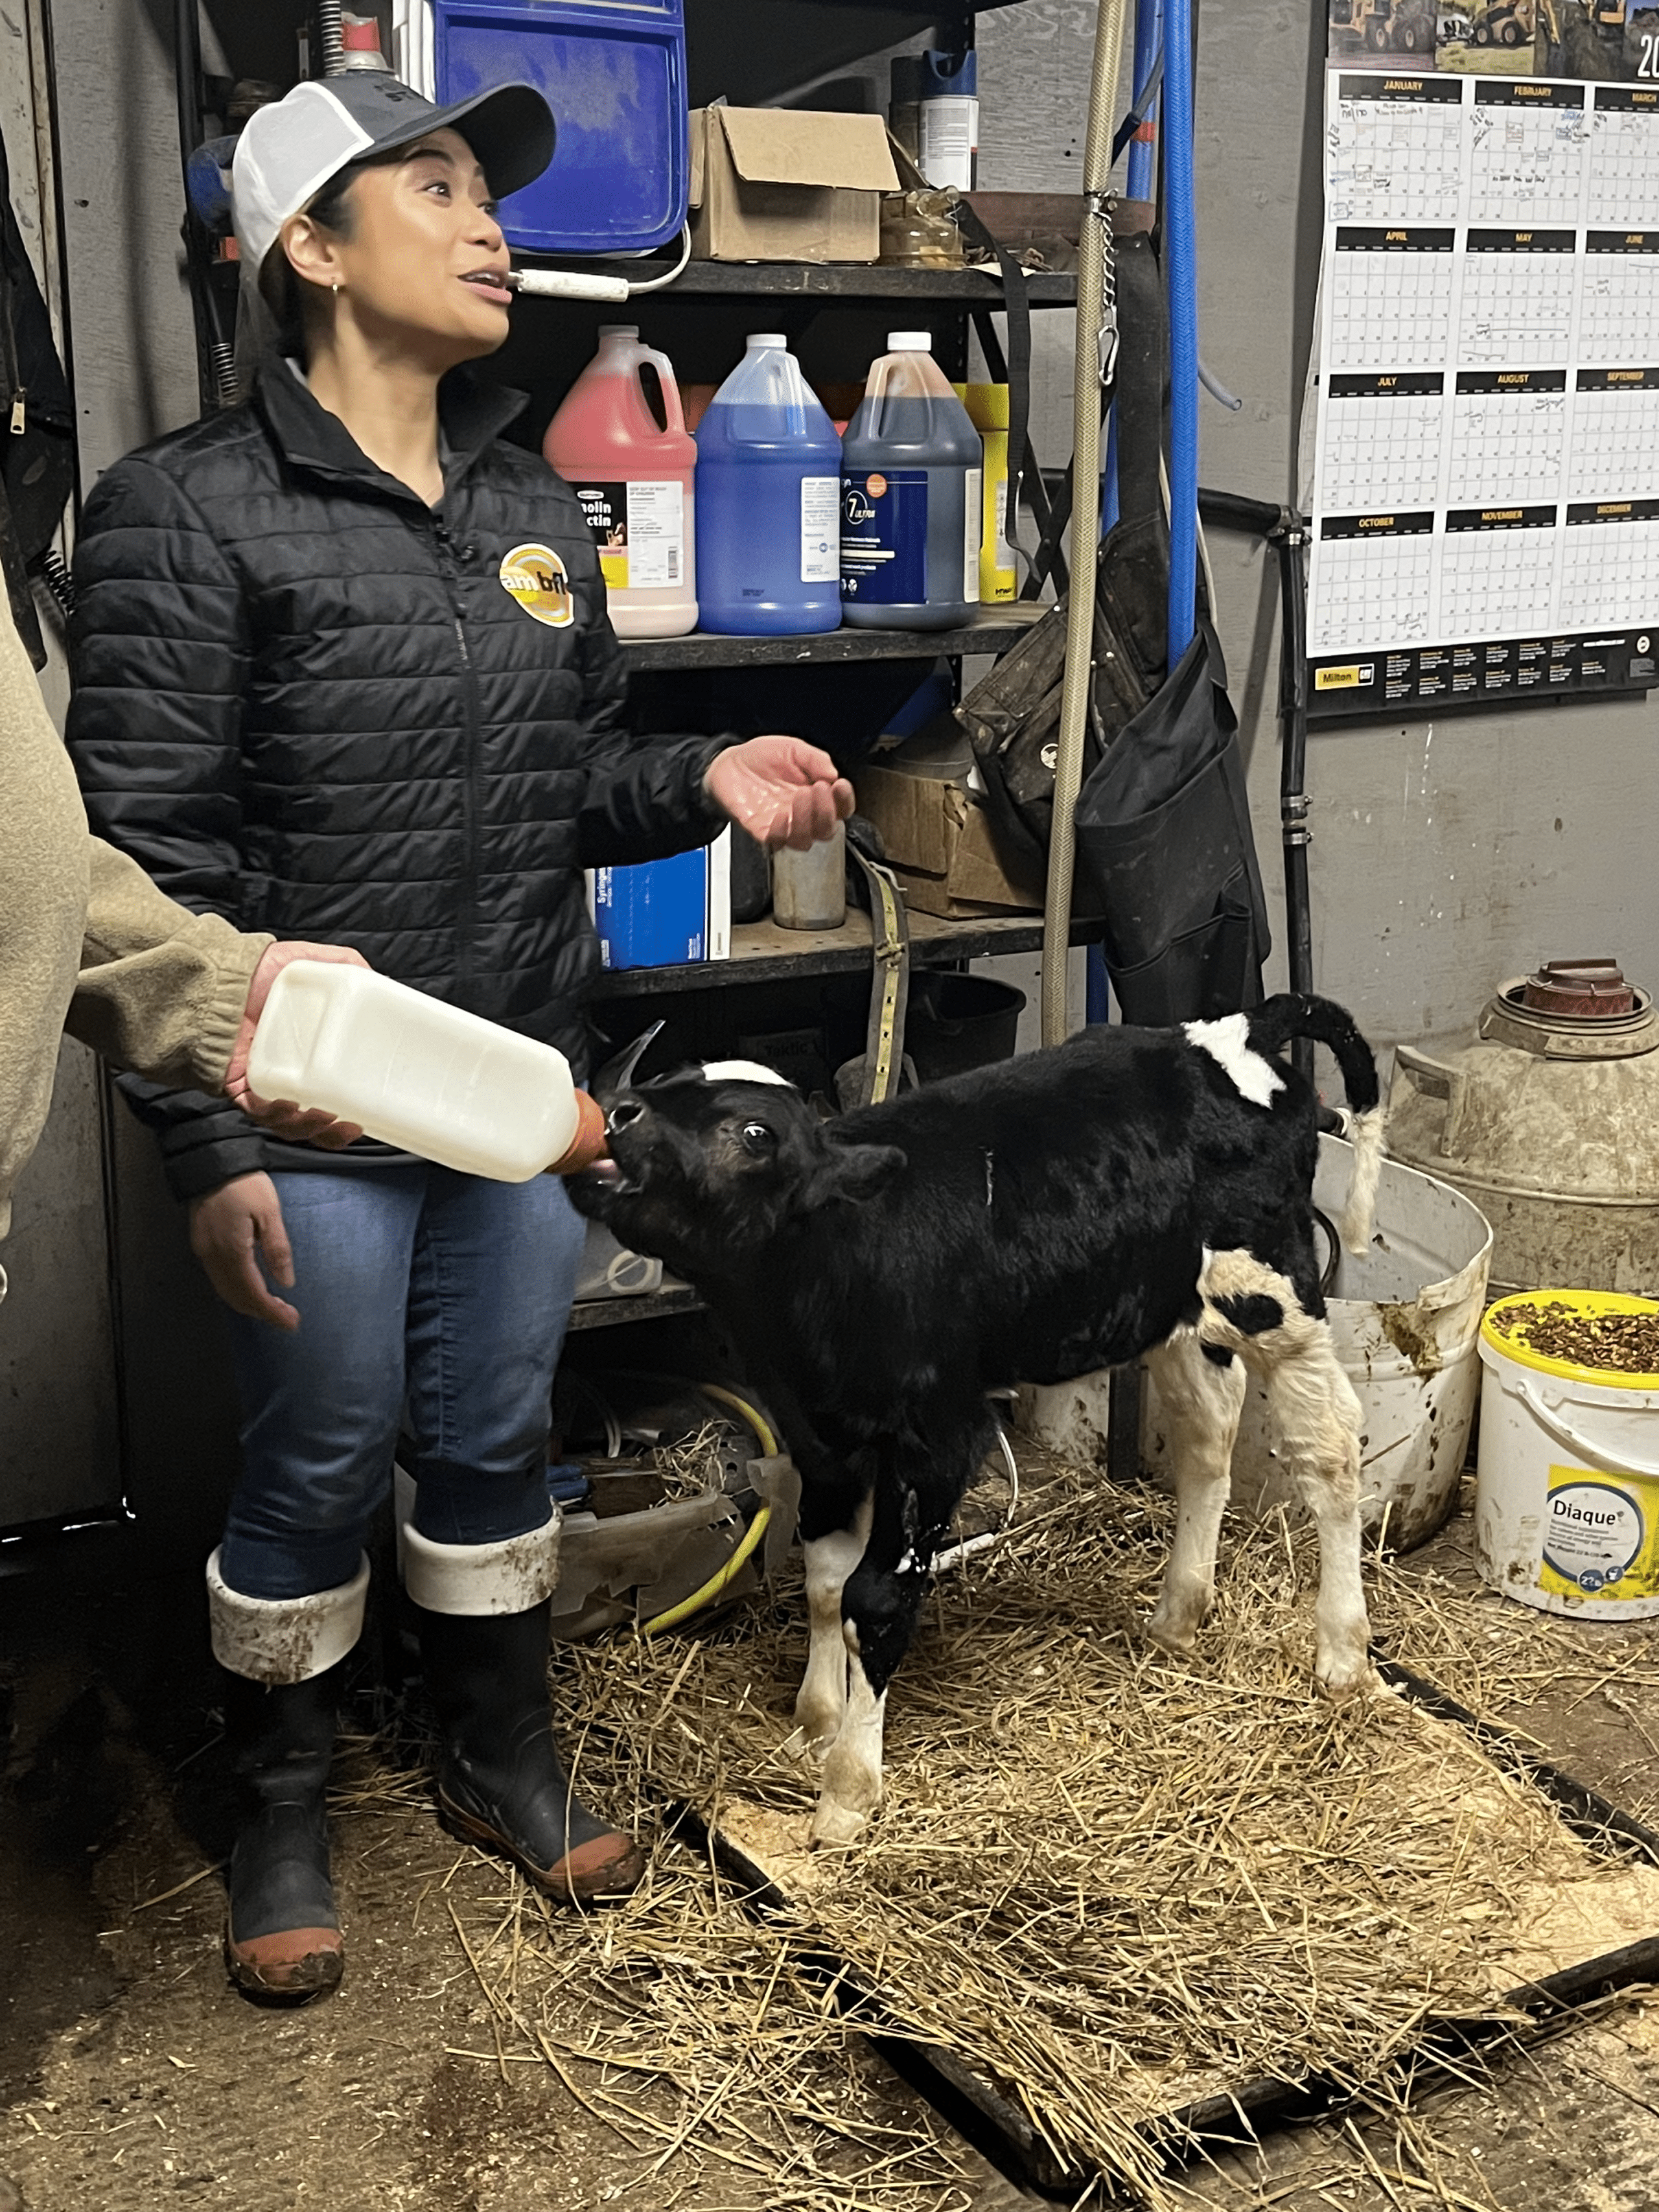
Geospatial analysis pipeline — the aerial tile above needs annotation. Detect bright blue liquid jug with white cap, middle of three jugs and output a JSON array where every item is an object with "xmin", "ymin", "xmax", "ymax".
[{"xmin": 697, "ymin": 332, "xmax": 841, "ymax": 637}]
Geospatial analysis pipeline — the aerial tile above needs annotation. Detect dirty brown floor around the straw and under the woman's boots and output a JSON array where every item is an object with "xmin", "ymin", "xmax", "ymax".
[{"xmin": 0, "ymin": 1522, "xmax": 1659, "ymax": 2212}]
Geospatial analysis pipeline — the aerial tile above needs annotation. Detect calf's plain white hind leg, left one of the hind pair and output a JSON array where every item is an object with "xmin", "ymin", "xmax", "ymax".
[{"xmin": 1146, "ymin": 1327, "xmax": 1246, "ymax": 1653}]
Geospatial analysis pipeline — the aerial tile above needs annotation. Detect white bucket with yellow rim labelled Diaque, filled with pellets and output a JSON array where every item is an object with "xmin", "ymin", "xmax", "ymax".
[{"xmin": 1476, "ymin": 1290, "xmax": 1659, "ymax": 1622}]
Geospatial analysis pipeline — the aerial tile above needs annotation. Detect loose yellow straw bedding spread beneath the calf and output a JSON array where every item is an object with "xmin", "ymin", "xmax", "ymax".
[{"xmin": 402, "ymin": 1453, "xmax": 1659, "ymax": 2212}]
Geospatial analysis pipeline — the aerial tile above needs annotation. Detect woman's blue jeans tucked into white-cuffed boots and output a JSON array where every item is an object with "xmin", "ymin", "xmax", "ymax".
[{"xmin": 219, "ymin": 1161, "xmax": 584, "ymax": 1597}]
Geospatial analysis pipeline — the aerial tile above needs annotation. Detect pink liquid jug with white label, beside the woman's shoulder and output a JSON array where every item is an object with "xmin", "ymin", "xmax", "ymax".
[{"xmin": 542, "ymin": 323, "xmax": 697, "ymax": 637}]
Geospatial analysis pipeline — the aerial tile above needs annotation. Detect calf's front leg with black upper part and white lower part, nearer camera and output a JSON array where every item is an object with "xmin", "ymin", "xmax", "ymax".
[{"xmin": 812, "ymin": 1449, "xmax": 973, "ymax": 1847}]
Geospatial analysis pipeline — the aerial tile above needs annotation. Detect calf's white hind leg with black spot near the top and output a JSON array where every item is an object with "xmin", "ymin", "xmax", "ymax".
[{"xmin": 1199, "ymin": 1252, "xmax": 1376, "ymax": 1697}]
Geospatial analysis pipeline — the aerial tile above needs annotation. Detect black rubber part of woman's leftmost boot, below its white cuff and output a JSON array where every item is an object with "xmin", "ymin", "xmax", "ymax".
[{"xmin": 226, "ymin": 1661, "xmax": 345, "ymax": 2002}]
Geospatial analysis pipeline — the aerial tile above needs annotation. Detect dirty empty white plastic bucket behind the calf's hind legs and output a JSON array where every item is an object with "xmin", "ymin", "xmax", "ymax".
[{"xmin": 1141, "ymin": 1137, "xmax": 1491, "ymax": 1551}]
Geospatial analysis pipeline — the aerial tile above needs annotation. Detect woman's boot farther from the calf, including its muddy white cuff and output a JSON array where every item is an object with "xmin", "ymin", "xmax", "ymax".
[{"xmin": 208, "ymin": 1551, "xmax": 369, "ymax": 2002}]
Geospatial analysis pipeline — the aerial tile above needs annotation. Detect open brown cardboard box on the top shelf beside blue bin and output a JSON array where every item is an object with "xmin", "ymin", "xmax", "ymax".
[{"xmin": 690, "ymin": 108, "xmax": 898, "ymax": 261}]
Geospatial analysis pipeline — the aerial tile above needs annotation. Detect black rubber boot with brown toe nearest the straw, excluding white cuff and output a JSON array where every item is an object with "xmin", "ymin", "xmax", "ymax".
[{"xmin": 413, "ymin": 1600, "xmax": 646, "ymax": 1905}]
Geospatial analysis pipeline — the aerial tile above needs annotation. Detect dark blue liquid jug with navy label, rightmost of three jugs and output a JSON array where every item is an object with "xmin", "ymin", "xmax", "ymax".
[{"xmin": 841, "ymin": 330, "xmax": 984, "ymax": 631}]
